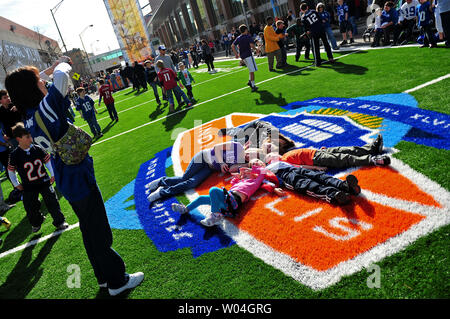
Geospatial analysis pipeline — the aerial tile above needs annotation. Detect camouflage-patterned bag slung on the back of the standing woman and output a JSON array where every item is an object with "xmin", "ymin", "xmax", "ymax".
[{"xmin": 35, "ymin": 111, "xmax": 92, "ymax": 165}]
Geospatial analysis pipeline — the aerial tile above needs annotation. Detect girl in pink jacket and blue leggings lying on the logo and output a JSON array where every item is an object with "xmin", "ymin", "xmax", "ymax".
[{"xmin": 172, "ymin": 159, "xmax": 285, "ymax": 227}]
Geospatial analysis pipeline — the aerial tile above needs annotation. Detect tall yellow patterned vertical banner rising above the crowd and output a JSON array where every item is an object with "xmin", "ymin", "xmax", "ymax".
[{"xmin": 103, "ymin": 0, "xmax": 152, "ymax": 62}]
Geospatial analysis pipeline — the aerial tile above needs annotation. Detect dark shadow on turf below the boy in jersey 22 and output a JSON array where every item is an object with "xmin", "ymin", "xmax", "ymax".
[{"xmin": 0, "ymin": 234, "xmax": 59, "ymax": 299}]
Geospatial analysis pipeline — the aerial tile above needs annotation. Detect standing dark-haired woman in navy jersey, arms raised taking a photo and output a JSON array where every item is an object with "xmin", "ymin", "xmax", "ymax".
[{"xmin": 5, "ymin": 57, "xmax": 144, "ymax": 296}]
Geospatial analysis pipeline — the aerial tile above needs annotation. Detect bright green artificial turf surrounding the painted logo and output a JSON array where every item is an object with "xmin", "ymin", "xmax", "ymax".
[{"xmin": 0, "ymin": 47, "xmax": 450, "ymax": 299}]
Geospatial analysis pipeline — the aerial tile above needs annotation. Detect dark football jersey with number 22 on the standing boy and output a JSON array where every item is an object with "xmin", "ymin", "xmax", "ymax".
[{"xmin": 8, "ymin": 144, "xmax": 50, "ymax": 190}]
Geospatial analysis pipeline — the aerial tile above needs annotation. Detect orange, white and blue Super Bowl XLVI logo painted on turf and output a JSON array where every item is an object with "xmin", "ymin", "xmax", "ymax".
[{"xmin": 106, "ymin": 94, "xmax": 450, "ymax": 290}]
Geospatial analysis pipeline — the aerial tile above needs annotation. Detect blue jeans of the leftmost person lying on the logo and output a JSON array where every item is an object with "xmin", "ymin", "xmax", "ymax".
[{"xmin": 159, "ymin": 149, "xmax": 214, "ymax": 198}]
